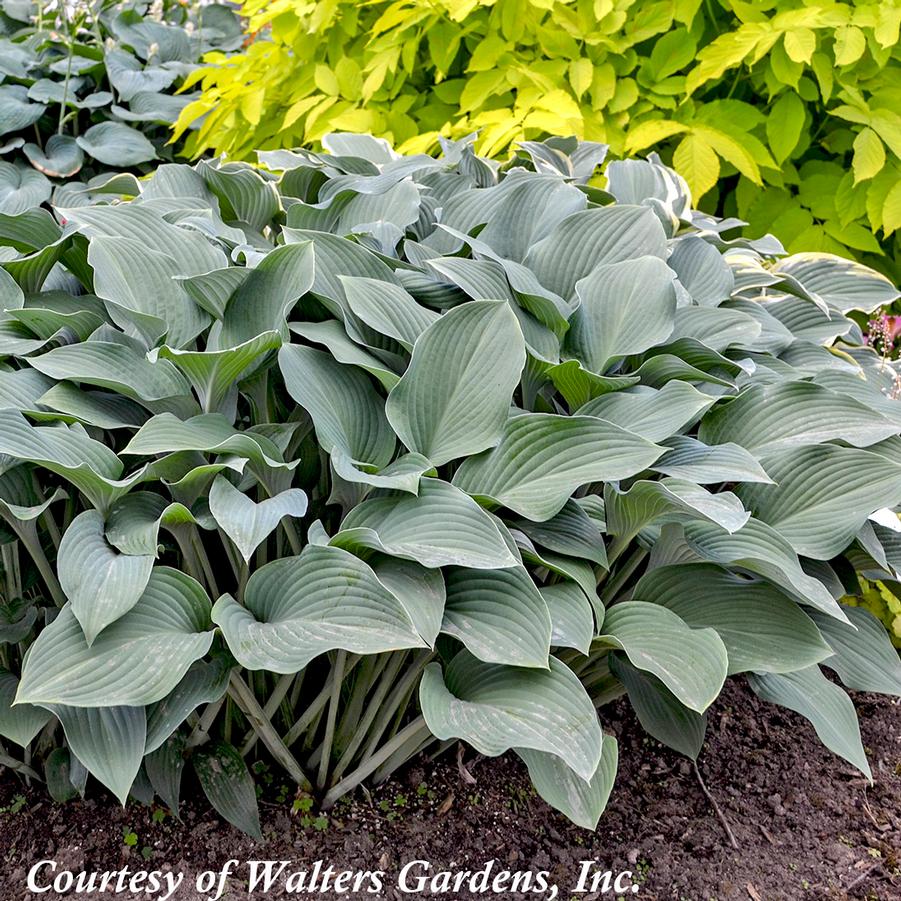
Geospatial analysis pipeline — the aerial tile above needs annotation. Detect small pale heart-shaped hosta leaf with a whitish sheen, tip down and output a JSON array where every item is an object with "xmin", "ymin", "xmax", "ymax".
[{"xmin": 210, "ymin": 476, "xmax": 307, "ymax": 564}]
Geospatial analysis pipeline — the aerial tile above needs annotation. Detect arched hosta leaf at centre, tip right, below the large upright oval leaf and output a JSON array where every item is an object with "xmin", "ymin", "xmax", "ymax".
[{"xmin": 331, "ymin": 478, "xmax": 519, "ymax": 569}]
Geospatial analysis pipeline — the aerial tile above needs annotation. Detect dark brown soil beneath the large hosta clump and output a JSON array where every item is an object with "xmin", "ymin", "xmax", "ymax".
[{"xmin": 0, "ymin": 683, "xmax": 901, "ymax": 901}]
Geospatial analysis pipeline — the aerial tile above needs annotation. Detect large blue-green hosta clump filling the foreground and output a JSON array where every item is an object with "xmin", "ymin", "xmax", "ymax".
[{"xmin": 0, "ymin": 135, "xmax": 901, "ymax": 835}]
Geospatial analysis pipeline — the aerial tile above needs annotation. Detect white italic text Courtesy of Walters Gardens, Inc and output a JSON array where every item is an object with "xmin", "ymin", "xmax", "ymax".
[{"xmin": 26, "ymin": 859, "xmax": 639, "ymax": 901}]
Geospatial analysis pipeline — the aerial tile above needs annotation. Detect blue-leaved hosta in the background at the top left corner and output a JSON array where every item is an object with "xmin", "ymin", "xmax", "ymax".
[{"xmin": 0, "ymin": 0, "xmax": 243, "ymax": 215}]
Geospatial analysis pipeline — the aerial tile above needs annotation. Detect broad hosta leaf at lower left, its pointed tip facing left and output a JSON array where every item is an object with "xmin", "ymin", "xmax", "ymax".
[{"xmin": 16, "ymin": 563, "xmax": 213, "ymax": 707}]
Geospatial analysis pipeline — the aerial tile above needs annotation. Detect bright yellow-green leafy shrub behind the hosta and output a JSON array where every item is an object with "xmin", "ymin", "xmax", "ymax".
[{"xmin": 175, "ymin": 0, "xmax": 901, "ymax": 281}]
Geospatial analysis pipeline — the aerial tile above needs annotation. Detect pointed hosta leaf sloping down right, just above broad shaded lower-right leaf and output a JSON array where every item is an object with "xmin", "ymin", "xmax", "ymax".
[{"xmin": 684, "ymin": 517, "xmax": 847, "ymax": 621}]
